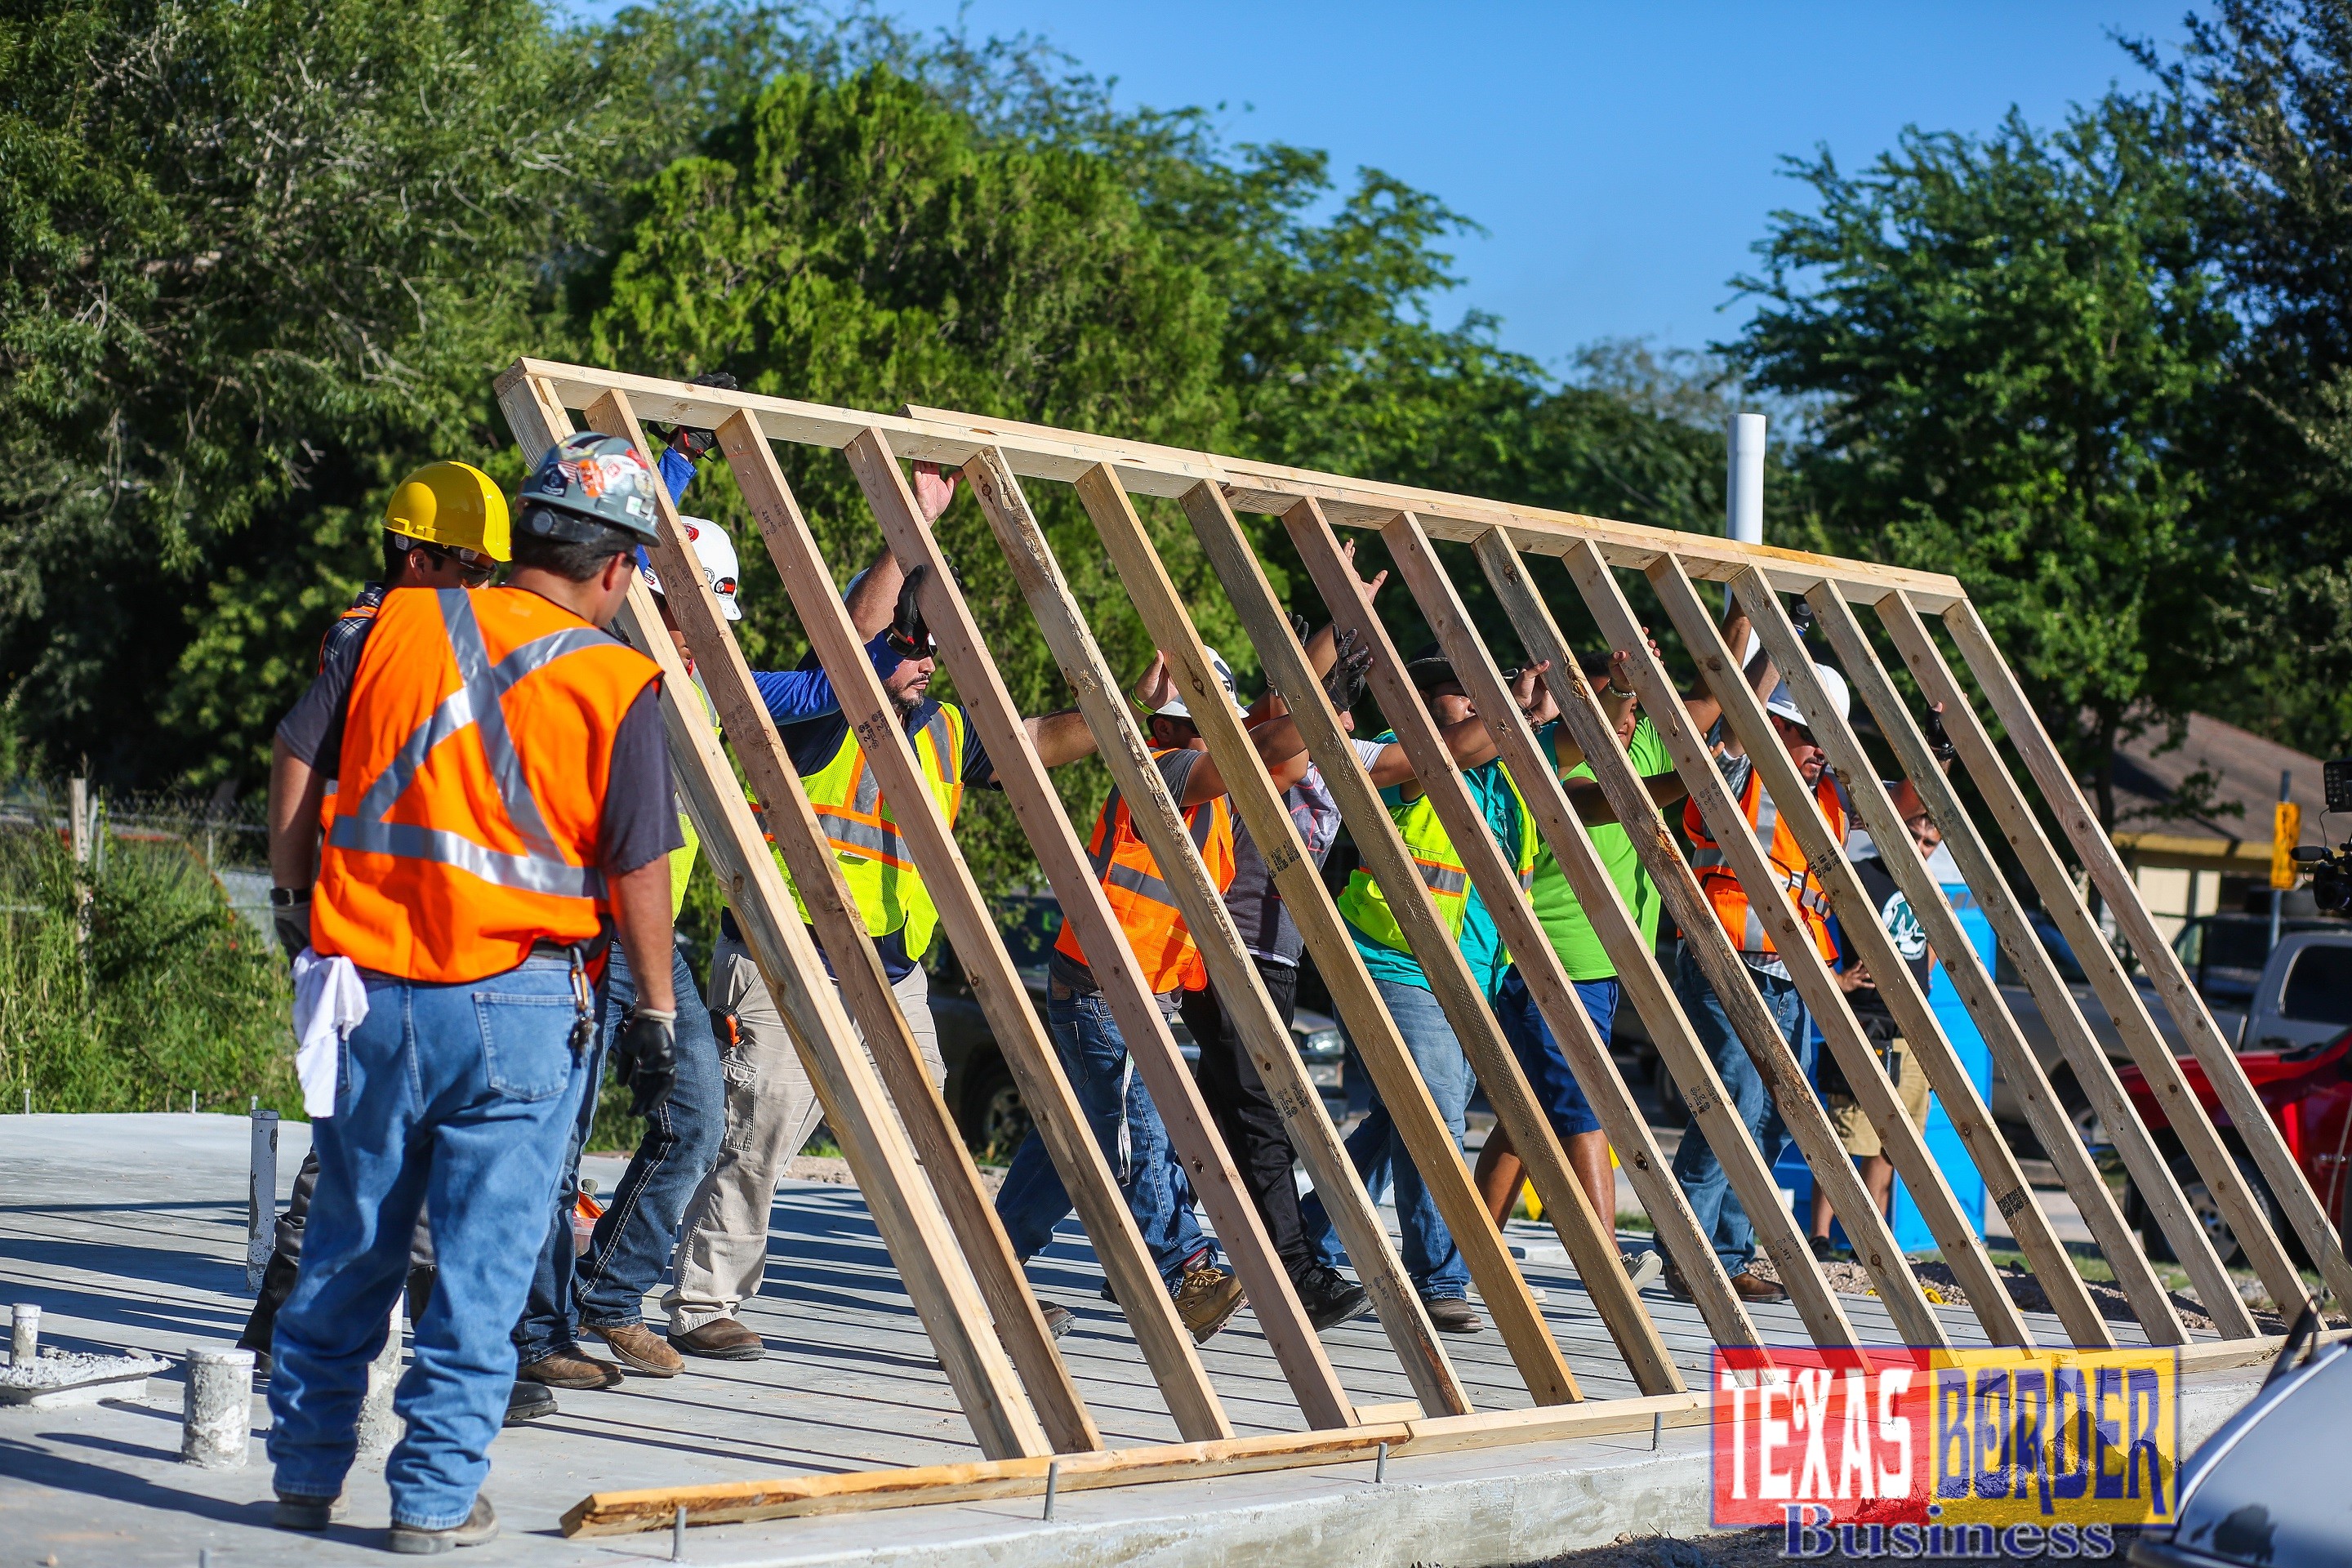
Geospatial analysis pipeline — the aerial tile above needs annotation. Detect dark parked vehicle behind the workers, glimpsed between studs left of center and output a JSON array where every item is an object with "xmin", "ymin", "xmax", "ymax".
[{"xmin": 929, "ymin": 893, "xmax": 1348, "ymax": 1159}]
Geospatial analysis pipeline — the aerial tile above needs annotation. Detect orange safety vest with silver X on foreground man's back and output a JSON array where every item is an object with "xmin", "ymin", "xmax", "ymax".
[{"xmin": 310, "ymin": 588, "xmax": 658, "ymax": 985}]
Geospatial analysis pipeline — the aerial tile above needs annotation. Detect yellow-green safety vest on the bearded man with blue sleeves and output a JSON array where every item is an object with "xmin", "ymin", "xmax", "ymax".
[{"xmin": 776, "ymin": 703, "xmax": 964, "ymax": 959}]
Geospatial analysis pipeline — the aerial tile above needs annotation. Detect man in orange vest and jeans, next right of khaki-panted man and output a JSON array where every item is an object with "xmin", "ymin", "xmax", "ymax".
[{"xmin": 997, "ymin": 651, "xmax": 1307, "ymax": 1343}]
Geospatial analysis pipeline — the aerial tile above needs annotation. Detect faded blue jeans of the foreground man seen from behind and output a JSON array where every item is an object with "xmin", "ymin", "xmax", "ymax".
[{"xmin": 270, "ymin": 957, "xmax": 588, "ymax": 1530}]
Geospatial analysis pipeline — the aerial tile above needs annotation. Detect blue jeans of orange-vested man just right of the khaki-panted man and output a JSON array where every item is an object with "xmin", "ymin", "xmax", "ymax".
[{"xmin": 997, "ymin": 982, "xmax": 1216, "ymax": 1290}]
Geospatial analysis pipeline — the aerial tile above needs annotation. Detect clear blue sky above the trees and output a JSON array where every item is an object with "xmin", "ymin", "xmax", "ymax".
[{"xmin": 818, "ymin": 0, "xmax": 2187, "ymax": 369}]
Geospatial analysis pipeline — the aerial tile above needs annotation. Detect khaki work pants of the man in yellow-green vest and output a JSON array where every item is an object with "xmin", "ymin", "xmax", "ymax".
[{"xmin": 661, "ymin": 936, "xmax": 948, "ymax": 1335}]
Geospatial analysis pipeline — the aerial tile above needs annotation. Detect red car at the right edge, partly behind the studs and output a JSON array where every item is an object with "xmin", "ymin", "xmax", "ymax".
[{"xmin": 2117, "ymin": 1032, "xmax": 2352, "ymax": 1265}]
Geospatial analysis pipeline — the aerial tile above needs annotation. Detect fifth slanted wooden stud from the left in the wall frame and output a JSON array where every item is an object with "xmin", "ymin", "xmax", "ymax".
[{"xmin": 951, "ymin": 449, "xmax": 1470, "ymax": 1420}]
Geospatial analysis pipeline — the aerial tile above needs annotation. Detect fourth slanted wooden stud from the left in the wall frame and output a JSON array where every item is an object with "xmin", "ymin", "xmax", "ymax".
[{"xmin": 847, "ymin": 437, "xmax": 1355, "ymax": 1427}]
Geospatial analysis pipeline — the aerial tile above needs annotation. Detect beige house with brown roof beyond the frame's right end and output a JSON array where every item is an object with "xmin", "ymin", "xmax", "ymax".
[{"xmin": 2114, "ymin": 712, "xmax": 2326, "ymax": 938}]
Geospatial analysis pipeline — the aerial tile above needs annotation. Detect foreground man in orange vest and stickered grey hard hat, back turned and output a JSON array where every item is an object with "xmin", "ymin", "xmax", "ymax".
[{"xmin": 270, "ymin": 435, "xmax": 682, "ymax": 1554}]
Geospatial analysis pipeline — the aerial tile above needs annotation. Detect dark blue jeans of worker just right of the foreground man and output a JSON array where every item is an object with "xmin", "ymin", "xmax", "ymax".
[{"xmin": 515, "ymin": 942, "xmax": 727, "ymax": 1365}]
